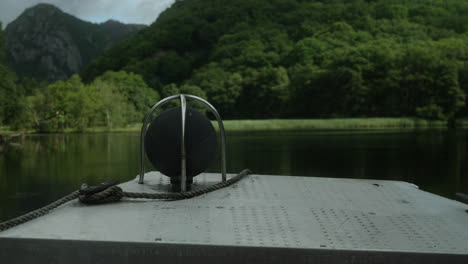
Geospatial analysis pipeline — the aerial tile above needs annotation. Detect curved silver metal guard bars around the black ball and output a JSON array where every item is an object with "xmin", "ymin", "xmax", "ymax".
[{"xmin": 138, "ymin": 94, "xmax": 227, "ymax": 188}]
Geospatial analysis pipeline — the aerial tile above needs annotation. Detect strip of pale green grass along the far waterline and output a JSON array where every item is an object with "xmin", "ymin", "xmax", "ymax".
[{"xmin": 0, "ymin": 118, "xmax": 468, "ymax": 134}]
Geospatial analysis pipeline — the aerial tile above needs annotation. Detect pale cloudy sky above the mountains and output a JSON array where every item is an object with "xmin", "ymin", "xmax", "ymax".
[{"xmin": 0, "ymin": 0, "xmax": 175, "ymax": 27}]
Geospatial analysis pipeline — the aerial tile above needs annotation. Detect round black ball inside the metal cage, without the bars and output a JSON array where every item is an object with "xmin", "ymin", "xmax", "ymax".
[{"xmin": 145, "ymin": 107, "xmax": 217, "ymax": 189}]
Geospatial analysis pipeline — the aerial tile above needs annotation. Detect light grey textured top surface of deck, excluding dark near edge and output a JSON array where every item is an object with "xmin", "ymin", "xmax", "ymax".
[{"xmin": 0, "ymin": 172, "xmax": 468, "ymax": 254}]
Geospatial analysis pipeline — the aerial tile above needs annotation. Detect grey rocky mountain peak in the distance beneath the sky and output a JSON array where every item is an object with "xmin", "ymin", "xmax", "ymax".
[{"xmin": 5, "ymin": 4, "xmax": 144, "ymax": 81}]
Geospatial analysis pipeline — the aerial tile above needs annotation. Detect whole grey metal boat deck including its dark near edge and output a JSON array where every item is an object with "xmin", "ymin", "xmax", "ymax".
[{"xmin": 0, "ymin": 172, "xmax": 468, "ymax": 264}]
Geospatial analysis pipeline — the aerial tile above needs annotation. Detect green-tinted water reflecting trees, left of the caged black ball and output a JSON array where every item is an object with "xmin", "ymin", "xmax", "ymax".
[{"xmin": 0, "ymin": 133, "xmax": 139, "ymax": 222}]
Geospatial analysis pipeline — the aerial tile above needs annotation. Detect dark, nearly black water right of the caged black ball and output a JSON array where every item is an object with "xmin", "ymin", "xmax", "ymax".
[{"xmin": 218, "ymin": 130, "xmax": 468, "ymax": 200}]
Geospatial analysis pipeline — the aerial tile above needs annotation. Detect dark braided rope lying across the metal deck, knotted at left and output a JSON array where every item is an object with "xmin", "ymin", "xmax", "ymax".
[{"xmin": 0, "ymin": 169, "xmax": 251, "ymax": 232}]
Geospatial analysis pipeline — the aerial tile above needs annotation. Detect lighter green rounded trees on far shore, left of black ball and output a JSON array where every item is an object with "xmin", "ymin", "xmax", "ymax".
[{"xmin": 15, "ymin": 72, "xmax": 159, "ymax": 132}]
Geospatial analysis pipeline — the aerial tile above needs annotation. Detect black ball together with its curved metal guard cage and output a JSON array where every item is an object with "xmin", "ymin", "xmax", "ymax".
[{"xmin": 139, "ymin": 94, "xmax": 226, "ymax": 191}]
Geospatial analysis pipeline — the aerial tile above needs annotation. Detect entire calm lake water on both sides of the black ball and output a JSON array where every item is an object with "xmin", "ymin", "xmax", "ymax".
[{"xmin": 0, "ymin": 130, "xmax": 468, "ymax": 221}]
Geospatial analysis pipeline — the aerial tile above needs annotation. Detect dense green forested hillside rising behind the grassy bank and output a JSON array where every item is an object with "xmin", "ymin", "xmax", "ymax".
[{"xmin": 82, "ymin": 0, "xmax": 468, "ymax": 119}]
